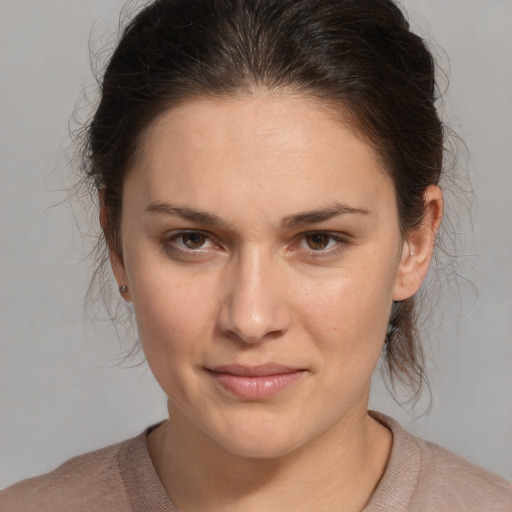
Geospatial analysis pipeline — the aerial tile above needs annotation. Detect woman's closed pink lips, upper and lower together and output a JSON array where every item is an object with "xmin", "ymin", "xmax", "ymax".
[{"xmin": 208, "ymin": 363, "xmax": 306, "ymax": 401}]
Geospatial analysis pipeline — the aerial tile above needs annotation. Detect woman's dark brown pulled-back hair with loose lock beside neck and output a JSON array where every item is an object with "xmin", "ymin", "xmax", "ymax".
[{"xmin": 82, "ymin": 0, "xmax": 444, "ymax": 395}]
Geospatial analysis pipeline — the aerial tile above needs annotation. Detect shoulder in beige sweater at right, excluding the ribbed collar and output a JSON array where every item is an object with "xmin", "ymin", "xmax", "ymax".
[{"xmin": 414, "ymin": 438, "xmax": 512, "ymax": 512}]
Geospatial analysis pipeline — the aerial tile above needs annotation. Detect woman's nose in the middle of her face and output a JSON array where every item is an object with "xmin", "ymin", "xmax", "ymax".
[{"xmin": 218, "ymin": 249, "xmax": 290, "ymax": 344}]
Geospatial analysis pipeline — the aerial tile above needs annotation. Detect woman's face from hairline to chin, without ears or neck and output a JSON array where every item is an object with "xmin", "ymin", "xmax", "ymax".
[{"xmin": 112, "ymin": 95, "xmax": 434, "ymax": 457}]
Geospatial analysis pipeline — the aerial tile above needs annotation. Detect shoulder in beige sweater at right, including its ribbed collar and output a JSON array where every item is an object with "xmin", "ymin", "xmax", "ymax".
[{"xmin": 365, "ymin": 411, "xmax": 512, "ymax": 512}]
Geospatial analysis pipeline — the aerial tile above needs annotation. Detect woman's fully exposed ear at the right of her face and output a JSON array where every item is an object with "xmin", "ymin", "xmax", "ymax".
[{"xmin": 393, "ymin": 185, "xmax": 443, "ymax": 301}]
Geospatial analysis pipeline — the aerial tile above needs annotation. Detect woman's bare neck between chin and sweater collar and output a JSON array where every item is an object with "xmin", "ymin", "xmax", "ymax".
[{"xmin": 148, "ymin": 404, "xmax": 392, "ymax": 512}]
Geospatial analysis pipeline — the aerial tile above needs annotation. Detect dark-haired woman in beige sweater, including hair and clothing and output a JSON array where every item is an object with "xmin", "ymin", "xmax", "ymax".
[{"xmin": 0, "ymin": 0, "xmax": 512, "ymax": 512}]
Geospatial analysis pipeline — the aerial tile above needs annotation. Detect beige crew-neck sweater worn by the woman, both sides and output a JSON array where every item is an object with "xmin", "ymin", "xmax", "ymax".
[{"xmin": 0, "ymin": 413, "xmax": 512, "ymax": 512}]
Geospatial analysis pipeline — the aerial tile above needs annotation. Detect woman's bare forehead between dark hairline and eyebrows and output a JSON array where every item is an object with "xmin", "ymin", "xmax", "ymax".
[{"xmin": 127, "ymin": 94, "xmax": 394, "ymax": 220}]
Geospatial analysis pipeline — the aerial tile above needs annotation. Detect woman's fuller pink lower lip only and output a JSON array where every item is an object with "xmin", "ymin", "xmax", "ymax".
[{"xmin": 210, "ymin": 370, "xmax": 305, "ymax": 401}]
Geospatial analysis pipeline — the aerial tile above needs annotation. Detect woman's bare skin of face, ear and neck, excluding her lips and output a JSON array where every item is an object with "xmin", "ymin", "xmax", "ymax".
[{"xmin": 106, "ymin": 93, "xmax": 442, "ymax": 512}]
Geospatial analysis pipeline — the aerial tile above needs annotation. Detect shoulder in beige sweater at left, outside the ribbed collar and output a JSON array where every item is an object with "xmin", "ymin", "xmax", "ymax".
[{"xmin": 0, "ymin": 436, "xmax": 142, "ymax": 512}]
